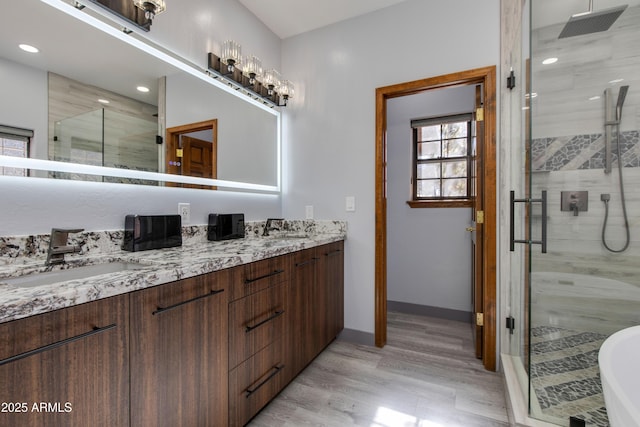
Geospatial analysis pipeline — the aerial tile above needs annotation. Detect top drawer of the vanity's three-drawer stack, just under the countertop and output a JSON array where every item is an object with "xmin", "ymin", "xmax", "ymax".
[{"xmin": 229, "ymin": 255, "xmax": 289, "ymax": 301}]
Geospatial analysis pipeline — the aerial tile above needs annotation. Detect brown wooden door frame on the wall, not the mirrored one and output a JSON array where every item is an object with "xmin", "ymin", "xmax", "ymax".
[{"xmin": 375, "ymin": 66, "xmax": 497, "ymax": 371}]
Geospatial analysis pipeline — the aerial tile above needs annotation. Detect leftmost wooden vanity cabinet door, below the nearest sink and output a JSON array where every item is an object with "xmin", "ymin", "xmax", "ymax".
[{"xmin": 0, "ymin": 295, "xmax": 129, "ymax": 427}]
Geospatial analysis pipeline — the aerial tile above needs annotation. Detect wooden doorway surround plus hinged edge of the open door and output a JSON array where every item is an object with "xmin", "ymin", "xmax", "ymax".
[{"xmin": 375, "ymin": 66, "xmax": 497, "ymax": 370}]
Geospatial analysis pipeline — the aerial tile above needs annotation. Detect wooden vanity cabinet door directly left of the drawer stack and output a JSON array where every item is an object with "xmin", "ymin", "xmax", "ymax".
[{"xmin": 131, "ymin": 272, "xmax": 228, "ymax": 427}]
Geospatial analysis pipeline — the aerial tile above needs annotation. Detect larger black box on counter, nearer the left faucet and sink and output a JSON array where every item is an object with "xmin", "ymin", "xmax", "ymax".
[{"xmin": 122, "ymin": 215, "xmax": 182, "ymax": 252}]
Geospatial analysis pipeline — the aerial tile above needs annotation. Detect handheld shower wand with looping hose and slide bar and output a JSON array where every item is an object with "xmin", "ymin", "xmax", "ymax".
[{"xmin": 600, "ymin": 86, "xmax": 631, "ymax": 253}]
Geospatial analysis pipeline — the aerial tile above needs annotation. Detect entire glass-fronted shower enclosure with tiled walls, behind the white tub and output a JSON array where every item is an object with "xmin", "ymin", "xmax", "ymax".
[{"xmin": 502, "ymin": 0, "xmax": 640, "ymax": 426}]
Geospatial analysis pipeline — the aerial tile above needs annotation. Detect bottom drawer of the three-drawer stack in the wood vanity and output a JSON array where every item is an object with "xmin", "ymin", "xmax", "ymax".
[{"xmin": 229, "ymin": 340, "xmax": 289, "ymax": 426}]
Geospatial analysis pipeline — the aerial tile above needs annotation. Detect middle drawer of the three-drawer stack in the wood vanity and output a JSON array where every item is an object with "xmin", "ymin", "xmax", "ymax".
[{"xmin": 229, "ymin": 283, "xmax": 287, "ymax": 368}]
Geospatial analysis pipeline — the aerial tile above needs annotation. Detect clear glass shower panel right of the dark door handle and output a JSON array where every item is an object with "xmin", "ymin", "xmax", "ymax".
[{"xmin": 525, "ymin": 0, "xmax": 640, "ymax": 426}]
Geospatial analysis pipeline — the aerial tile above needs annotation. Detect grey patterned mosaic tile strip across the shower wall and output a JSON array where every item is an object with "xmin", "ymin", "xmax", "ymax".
[{"xmin": 531, "ymin": 130, "xmax": 640, "ymax": 171}]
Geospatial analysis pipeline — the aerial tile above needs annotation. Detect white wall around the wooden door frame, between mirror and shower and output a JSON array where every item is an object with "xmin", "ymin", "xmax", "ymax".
[{"xmin": 282, "ymin": 0, "xmax": 500, "ymax": 333}]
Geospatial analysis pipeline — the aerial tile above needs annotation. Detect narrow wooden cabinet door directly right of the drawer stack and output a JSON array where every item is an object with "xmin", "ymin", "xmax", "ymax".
[{"xmin": 288, "ymin": 248, "xmax": 318, "ymax": 375}]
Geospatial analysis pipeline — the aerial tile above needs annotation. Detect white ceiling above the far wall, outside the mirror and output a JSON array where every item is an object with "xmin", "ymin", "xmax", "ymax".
[{"xmin": 239, "ymin": 0, "xmax": 406, "ymax": 39}]
